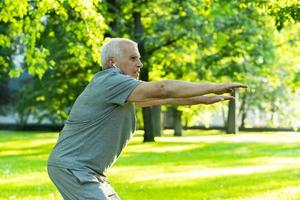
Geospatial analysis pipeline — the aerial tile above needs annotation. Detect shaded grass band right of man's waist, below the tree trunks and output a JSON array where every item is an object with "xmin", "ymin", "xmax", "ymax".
[{"xmin": 116, "ymin": 142, "xmax": 300, "ymax": 167}]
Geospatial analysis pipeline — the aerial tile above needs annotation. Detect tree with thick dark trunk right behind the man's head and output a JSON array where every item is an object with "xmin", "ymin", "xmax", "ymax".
[{"xmin": 101, "ymin": 0, "xmax": 211, "ymax": 141}]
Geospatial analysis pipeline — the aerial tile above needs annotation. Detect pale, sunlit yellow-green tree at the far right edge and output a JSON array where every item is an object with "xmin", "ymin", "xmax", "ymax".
[{"xmin": 240, "ymin": 1, "xmax": 300, "ymax": 127}]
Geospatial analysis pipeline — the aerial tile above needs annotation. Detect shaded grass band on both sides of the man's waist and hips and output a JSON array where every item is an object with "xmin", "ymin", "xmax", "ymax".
[{"xmin": 0, "ymin": 142, "xmax": 300, "ymax": 171}]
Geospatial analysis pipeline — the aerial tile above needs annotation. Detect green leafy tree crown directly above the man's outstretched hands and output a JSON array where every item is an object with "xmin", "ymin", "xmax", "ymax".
[{"xmin": 152, "ymin": 1, "xmax": 274, "ymax": 134}]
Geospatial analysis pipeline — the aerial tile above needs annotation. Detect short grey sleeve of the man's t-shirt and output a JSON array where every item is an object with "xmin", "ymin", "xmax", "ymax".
[{"xmin": 105, "ymin": 74, "xmax": 142, "ymax": 105}]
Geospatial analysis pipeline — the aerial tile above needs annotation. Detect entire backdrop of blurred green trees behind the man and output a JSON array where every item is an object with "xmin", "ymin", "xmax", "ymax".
[{"xmin": 0, "ymin": 0, "xmax": 300, "ymax": 141}]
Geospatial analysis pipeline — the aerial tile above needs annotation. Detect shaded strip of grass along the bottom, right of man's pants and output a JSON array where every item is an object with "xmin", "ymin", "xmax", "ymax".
[{"xmin": 112, "ymin": 169, "xmax": 300, "ymax": 200}]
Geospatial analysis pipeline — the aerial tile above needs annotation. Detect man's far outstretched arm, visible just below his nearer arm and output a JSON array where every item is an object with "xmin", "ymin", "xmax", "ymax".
[{"xmin": 135, "ymin": 95, "xmax": 234, "ymax": 107}]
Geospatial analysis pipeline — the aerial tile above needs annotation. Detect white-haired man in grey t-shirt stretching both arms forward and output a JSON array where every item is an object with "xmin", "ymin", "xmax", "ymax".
[{"xmin": 48, "ymin": 38, "xmax": 246, "ymax": 200}]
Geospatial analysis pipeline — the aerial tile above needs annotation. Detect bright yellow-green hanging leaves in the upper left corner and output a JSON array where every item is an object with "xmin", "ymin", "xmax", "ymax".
[{"xmin": 0, "ymin": 0, "xmax": 106, "ymax": 78}]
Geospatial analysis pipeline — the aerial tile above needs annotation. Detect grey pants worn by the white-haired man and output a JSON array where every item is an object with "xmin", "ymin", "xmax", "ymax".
[{"xmin": 48, "ymin": 166, "xmax": 120, "ymax": 200}]
